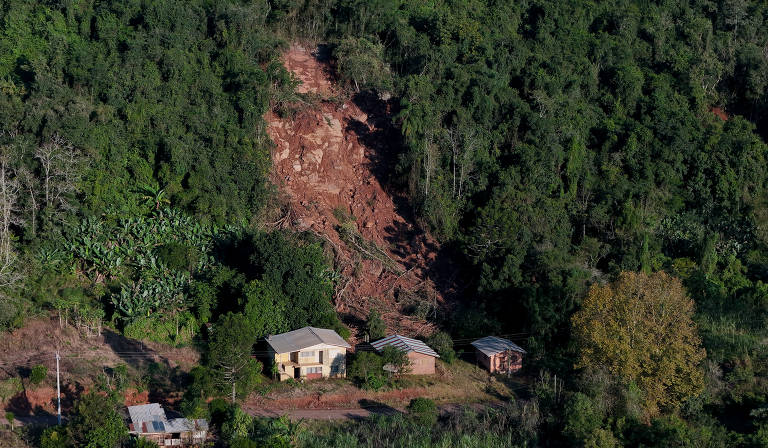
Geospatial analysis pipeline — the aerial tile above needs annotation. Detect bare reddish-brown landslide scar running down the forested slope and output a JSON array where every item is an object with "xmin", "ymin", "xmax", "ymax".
[{"xmin": 267, "ymin": 45, "xmax": 450, "ymax": 336}]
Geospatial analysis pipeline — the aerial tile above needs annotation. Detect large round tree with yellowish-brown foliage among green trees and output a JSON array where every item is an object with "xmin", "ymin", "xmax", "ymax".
[{"xmin": 572, "ymin": 272, "xmax": 705, "ymax": 415}]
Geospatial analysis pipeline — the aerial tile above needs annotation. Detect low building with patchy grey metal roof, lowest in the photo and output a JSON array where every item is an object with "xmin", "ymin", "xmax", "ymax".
[{"xmin": 128, "ymin": 403, "xmax": 208, "ymax": 446}]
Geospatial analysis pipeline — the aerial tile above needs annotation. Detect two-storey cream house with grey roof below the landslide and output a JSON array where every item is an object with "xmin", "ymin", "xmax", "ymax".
[{"xmin": 266, "ymin": 327, "xmax": 351, "ymax": 381}]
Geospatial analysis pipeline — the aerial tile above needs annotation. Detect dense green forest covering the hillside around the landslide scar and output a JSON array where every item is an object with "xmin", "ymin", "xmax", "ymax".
[{"xmin": 0, "ymin": 0, "xmax": 768, "ymax": 447}]
